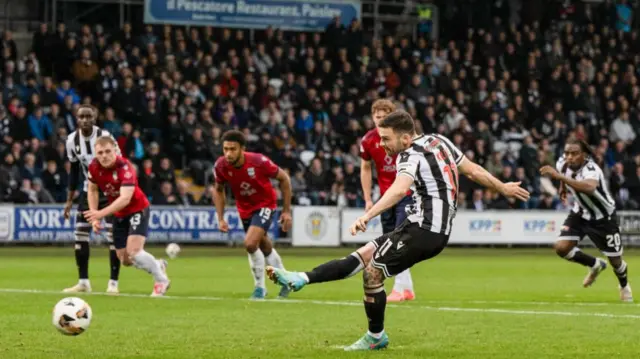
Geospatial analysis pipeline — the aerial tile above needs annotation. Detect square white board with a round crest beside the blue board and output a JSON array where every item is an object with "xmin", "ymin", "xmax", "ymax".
[{"xmin": 291, "ymin": 207, "xmax": 340, "ymax": 247}]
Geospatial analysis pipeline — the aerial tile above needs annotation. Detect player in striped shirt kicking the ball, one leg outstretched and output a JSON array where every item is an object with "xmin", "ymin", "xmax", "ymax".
[{"xmin": 267, "ymin": 111, "xmax": 529, "ymax": 351}]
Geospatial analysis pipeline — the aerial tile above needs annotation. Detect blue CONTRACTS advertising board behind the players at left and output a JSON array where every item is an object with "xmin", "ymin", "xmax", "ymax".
[{"xmin": 11, "ymin": 206, "xmax": 280, "ymax": 243}]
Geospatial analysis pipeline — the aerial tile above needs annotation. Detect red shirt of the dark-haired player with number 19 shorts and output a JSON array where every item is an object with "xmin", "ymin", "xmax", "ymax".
[{"xmin": 214, "ymin": 152, "xmax": 280, "ymax": 219}]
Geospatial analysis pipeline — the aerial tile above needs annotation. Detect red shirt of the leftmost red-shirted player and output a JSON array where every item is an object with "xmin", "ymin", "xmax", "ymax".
[{"xmin": 87, "ymin": 156, "xmax": 149, "ymax": 218}]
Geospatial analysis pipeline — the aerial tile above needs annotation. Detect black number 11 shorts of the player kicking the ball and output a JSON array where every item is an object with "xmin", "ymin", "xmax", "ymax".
[{"xmin": 371, "ymin": 221, "xmax": 449, "ymax": 278}]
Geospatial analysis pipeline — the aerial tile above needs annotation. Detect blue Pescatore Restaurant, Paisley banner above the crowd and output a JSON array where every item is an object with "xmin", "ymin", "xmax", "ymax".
[{"xmin": 144, "ymin": 0, "xmax": 361, "ymax": 31}]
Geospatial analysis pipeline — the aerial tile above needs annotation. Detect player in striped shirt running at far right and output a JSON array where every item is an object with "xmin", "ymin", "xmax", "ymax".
[{"xmin": 540, "ymin": 139, "xmax": 633, "ymax": 302}]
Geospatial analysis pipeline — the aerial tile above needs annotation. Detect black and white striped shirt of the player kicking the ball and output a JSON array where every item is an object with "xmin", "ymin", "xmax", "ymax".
[{"xmin": 396, "ymin": 134, "xmax": 464, "ymax": 235}]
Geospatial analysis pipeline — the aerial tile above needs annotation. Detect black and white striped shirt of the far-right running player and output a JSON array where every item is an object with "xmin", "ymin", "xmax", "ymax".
[{"xmin": 556, "ymin": 156, "xmax": 616, "ymax": 221}]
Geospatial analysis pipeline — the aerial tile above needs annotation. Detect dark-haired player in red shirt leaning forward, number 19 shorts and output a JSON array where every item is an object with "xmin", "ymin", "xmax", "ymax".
[{"xmin": 214, "ymin": 131, "xmax": 291, "ymax": 299}]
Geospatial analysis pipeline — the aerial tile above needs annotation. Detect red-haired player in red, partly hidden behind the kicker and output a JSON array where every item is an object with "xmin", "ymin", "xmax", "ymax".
[{"xmin": 360, "ymin": 100, "xmax": 416, "ymax": 302}]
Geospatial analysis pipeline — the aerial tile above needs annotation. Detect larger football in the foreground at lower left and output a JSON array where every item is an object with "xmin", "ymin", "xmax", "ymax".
[{"xmin": 53, "ymin": 297, "xmax": 93, "ymax": 335}]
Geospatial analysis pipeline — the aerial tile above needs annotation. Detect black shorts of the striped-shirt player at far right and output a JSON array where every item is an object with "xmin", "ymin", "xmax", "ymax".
[{"xmin": 558, "ymin": 213, "xmax": 623, "ymax": 257}]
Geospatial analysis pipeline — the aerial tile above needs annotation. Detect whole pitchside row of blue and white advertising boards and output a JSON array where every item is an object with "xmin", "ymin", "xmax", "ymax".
[{"xmin": 0, "ymin": 205, "xmax": 640, "ymax": 247}]
